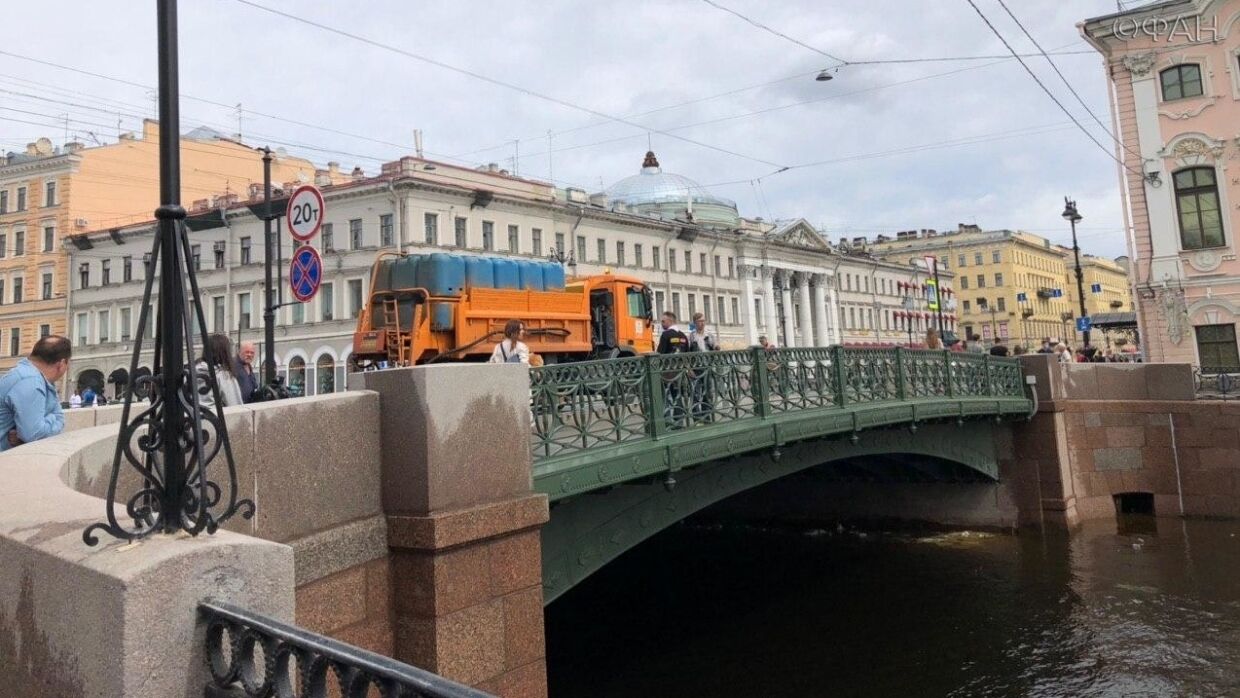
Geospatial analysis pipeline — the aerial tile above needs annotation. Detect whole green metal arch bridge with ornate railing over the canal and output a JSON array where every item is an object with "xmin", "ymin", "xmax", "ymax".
[{"xmin": 529, "ymin": 346, "xmax": 1033, "ymax": 603}]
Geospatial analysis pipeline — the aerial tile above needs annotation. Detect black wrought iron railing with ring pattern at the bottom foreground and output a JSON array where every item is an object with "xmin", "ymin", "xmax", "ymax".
[{"xmin": 198, "ymin": 603, "xmax": 492, "ymax": 698}]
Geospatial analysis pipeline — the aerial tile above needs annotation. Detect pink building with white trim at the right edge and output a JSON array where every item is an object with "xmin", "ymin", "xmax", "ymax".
[{"xmin": 1078, "ymin": 0, "xmax": 1240, "ymax": 372}]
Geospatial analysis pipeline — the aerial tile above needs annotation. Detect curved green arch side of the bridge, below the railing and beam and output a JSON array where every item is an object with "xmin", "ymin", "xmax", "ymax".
[{"xmin": 542, "ymin": 422, "xmax": 1007, "ymax": 604}]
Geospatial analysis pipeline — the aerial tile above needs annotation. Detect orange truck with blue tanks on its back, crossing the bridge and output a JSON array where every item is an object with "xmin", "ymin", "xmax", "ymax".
[{"xmin": 353, "ymin": 253, "xmax": 655, "ymax": 369}]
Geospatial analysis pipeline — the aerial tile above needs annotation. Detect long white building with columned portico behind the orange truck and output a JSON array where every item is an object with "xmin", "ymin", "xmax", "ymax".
[{"xmin": 68, "ymin": 157, "xmax": 852, "ymax": 395}]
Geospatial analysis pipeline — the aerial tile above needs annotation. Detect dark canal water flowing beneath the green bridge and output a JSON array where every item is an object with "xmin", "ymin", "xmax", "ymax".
[{"xmin": 547, "ymin": 518, "xmax": 1240, "ymax": 698}]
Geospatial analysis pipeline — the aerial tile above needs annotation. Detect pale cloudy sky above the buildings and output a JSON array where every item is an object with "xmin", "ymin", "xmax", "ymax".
[{"xmin": 0, "ymin": 0, "xmax": 1126, "ymax": 257}]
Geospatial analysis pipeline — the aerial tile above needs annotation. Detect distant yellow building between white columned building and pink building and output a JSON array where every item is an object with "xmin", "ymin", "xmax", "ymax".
[{"xmin": 870, "ymin": 226, "xmax": 1132, "ymax": 351}]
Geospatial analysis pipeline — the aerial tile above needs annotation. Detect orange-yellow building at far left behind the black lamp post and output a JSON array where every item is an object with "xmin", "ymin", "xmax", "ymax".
[{"xmin": 0, "ymin": 120, "xmax": 329, "ymax": 372}]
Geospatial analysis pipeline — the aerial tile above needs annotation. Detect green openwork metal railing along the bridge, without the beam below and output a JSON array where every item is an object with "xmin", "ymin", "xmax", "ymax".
[{"xmin": 529, "ymin": 346, "xmax": 1025, "ymax": 468}]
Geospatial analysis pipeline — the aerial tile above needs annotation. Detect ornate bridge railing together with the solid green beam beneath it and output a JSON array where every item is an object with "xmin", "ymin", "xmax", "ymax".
[{"xmin": 529, "ymin": 346, "xmax": 1030, "ymax": 488}]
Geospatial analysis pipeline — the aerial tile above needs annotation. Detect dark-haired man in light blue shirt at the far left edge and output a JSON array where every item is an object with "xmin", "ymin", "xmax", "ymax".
[{"xmin": 0, "ymin": 335, "xmax": 72, "ymax": 451}]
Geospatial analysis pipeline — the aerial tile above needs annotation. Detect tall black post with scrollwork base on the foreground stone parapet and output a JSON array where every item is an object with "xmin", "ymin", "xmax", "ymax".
[{"xmin": 82, "ymin": 0, "xmax": 254, "ymax": 546}]
